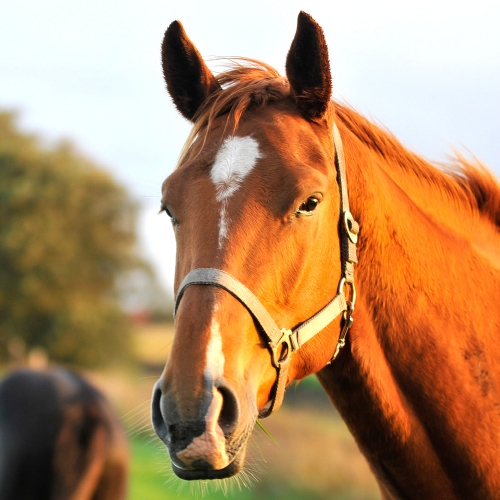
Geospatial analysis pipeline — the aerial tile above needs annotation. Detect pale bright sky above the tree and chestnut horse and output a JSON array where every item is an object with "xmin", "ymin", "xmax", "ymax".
[{"xmin": 0, "ymin": 0, "xmax": 500, "ymax": 291}]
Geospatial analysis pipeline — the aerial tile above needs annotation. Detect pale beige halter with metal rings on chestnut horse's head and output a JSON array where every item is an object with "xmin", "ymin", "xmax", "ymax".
[{"xmin": 174, "ymin": 124, "xmax": 359, "ymax": 418}]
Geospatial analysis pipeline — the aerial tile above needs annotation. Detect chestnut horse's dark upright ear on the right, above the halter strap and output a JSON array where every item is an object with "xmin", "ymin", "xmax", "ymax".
[{"xmin": 286, "ymin": 11, "xmax": 332, "ymax": 118}]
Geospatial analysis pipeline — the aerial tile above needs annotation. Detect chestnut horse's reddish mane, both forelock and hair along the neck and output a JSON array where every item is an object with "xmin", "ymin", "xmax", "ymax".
[{"xmin": 179, "ymin": 57, "xmax": 500, "ymax": 227}]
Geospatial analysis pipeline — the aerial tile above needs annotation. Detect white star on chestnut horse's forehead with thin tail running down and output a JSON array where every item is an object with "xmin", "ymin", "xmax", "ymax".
[{"xmin": 210, "ymin": 136, "xmax": 262, "ymax": 248}]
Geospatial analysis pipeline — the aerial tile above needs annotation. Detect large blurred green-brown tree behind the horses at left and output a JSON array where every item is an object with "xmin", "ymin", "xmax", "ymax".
[{"xmin": 0, "ymin": 113, "xmax": 150, "ymax": 366}]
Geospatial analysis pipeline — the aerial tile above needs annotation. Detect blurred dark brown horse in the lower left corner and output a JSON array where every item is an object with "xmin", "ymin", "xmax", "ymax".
[{"xmin": 0, "ymin": 368, "xmax": 128, "ymax": 500}]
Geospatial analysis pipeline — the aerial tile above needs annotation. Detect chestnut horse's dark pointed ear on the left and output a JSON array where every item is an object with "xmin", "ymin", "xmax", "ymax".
[{"xmin": 161, "ymin": 21, "xmax": 220, "ymax": 121}]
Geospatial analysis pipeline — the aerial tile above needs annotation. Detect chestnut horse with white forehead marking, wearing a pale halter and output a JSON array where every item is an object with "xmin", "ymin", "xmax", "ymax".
[{"xmin": 152, "ymin": 12, "xmax": 500, "ymax": 500}]
